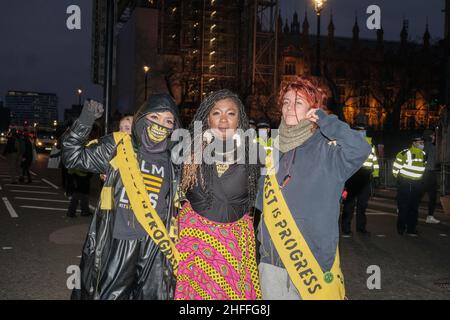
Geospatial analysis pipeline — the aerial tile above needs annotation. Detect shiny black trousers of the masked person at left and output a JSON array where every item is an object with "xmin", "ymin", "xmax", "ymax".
[{"xmin": 94, "ymin": 236, "xmax": 174, "ymax": 300}]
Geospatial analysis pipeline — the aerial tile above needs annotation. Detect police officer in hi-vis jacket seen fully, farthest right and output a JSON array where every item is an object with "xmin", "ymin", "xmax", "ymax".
[{"xmin": 392, "ymin": 135, "xmax": 426, "ymax": 237}]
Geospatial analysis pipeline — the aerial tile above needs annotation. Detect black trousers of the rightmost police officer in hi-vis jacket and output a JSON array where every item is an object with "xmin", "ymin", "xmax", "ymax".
[{"xmin": 397, "ymin": 178, "xmax": 423, "ymax": 234}]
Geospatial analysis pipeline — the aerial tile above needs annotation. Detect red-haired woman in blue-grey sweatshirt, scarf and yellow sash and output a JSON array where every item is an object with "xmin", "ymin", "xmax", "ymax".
[{"xmin": 256, "ymin": 77, "xmax": 370, "ymax": 300}]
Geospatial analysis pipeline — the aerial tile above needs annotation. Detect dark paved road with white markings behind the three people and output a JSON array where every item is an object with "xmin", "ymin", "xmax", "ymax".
[{"xmin": 0, "ymin": 154, "xmax": 450, "ymax": 299}]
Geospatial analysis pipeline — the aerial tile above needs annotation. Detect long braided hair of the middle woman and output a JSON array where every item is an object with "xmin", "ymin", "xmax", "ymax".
[{"xmin": 181, "ymin": 89, "xmax": 259, "ymax": 209}]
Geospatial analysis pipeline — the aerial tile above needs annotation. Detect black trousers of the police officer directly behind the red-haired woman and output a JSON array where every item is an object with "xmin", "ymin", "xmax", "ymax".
[{"xmin": 341, "ymin": 179, "xmax": 370, "ymax": 233}]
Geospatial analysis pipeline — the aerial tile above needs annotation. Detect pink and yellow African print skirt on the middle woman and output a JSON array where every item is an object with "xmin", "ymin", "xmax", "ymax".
[{"xmin": 175, "ymin": 202, "xmax": 261, "ymax": 300}]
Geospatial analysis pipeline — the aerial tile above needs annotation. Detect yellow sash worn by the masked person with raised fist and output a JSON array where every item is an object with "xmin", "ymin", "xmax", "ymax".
[{"xmin": 111, "ymin": 132, "xmax": 180, "ymax": 275}]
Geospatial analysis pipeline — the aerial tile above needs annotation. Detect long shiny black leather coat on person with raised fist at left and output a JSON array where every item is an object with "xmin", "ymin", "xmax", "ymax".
[{"xmin": 62, "ymin": 94, "xmax": 178, "ymax": 300}]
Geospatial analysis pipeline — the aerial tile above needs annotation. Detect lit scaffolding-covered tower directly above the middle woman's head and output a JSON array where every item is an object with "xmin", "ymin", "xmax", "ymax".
[{"xmin": 159, "ymin": 0, "xmax": 245, "ymax": 105}]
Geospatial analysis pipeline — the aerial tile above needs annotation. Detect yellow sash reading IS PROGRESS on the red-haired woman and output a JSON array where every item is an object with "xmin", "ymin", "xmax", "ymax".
[{"xmin": 263, "ymin": 157, "xmax": 345, "ymax": 300}]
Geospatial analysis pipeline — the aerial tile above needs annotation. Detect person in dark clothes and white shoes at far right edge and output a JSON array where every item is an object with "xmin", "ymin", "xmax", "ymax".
[{"xmin": 422, "ymin": 130, "xmax": 440, "ymax": 224}]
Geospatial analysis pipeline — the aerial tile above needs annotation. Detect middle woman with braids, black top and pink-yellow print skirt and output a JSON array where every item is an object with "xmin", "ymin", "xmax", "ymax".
[{"xmin": 175, "ymin": 90, "xmax": 261, "ymax": 300}]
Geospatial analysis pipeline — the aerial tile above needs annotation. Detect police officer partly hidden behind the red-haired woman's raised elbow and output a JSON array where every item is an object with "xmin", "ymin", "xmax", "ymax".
[{"xmin": 341, "ymin": 124, "xmax": 380, "ymax": 238}]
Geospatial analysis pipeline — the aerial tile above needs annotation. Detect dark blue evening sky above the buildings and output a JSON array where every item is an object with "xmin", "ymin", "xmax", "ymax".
[{"xmin": 0, "ymin": 0, "xmax": 444, "ymax": 120}]
